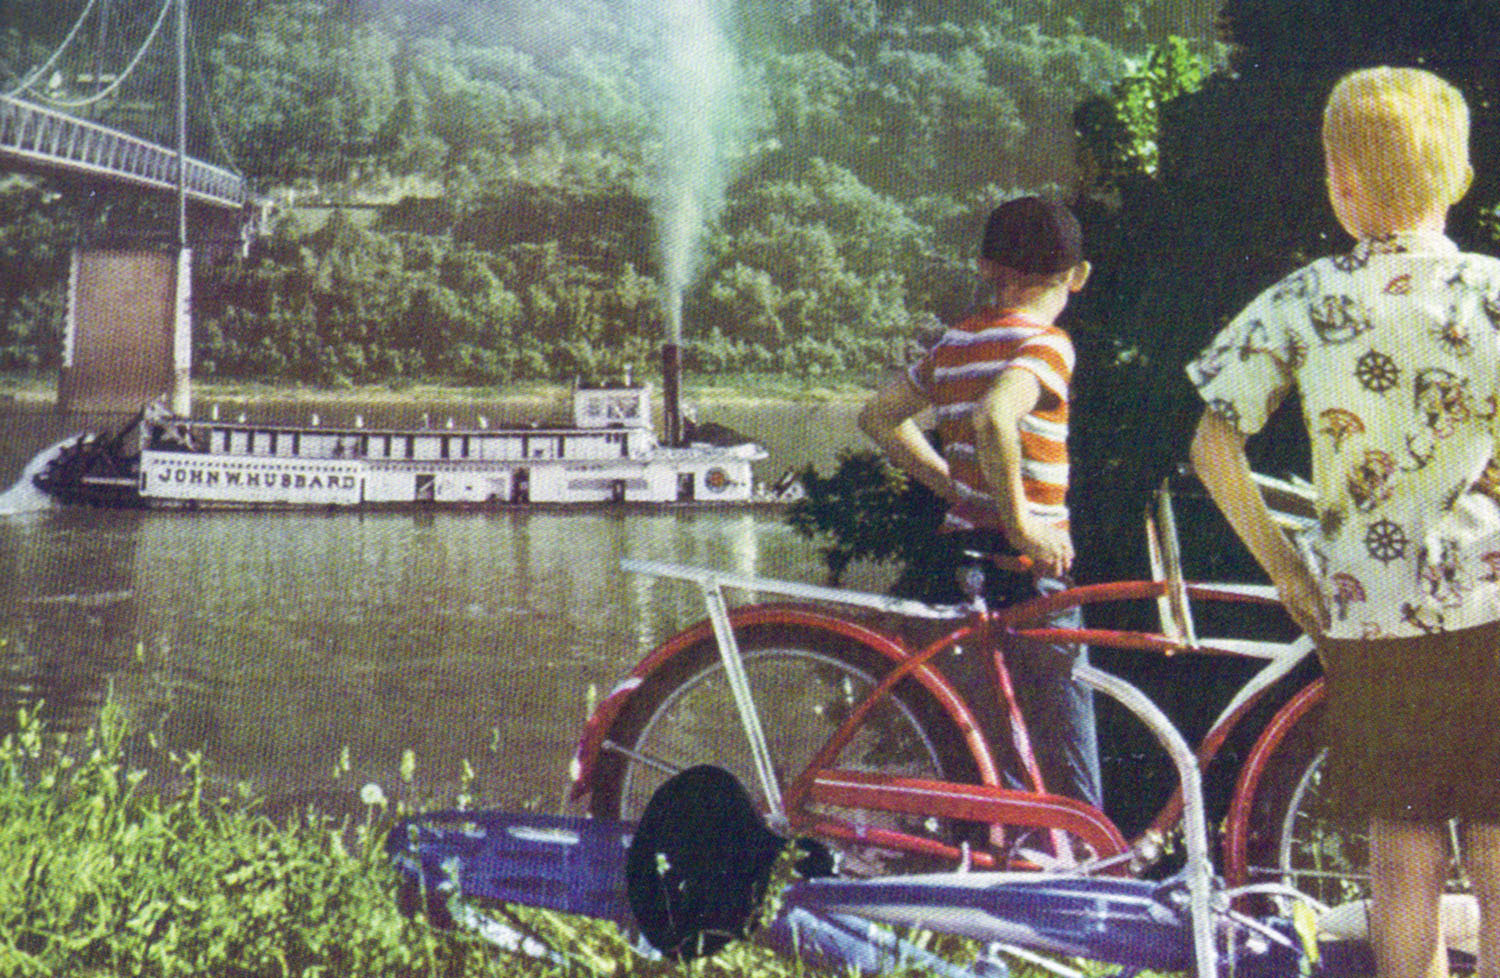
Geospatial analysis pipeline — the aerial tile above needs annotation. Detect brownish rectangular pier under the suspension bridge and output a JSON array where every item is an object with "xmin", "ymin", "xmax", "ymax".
[{"xmin": 57, "ymin": 248, "xmax": 192, "ymax": 416}]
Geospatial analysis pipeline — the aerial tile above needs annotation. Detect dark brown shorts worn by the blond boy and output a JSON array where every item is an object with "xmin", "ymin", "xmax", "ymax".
[{"xmin": 1319, "ymin": 623, "xmax": 1500, "ymax": 822}]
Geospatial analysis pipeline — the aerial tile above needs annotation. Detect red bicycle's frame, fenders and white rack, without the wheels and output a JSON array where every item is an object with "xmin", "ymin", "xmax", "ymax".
[{"xmin": 573, "ymin": 480, "xmax": 1322, "ymax": 885}]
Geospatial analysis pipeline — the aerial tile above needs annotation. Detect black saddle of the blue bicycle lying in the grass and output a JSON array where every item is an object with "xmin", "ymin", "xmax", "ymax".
[{"xmin": 626, "ymin": 765, "xmax": 833, "ymax": 960}]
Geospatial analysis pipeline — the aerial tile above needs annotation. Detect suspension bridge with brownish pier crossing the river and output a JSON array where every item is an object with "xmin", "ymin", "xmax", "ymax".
[{"xmin": 0, "ymin": 0, "xmax": 255, "ymax": 414}]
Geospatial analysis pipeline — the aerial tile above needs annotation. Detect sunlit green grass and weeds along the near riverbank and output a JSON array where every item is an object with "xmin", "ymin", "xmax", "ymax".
[{"xmin": 0, "ymin": 704, "xmax": 1104, "ymax": 978}]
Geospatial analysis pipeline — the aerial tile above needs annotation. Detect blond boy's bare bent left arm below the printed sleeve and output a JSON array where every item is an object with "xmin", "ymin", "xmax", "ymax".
[{"xmin": 1191, "ymin": 411, "xmax": 1329, "ymax": 635}]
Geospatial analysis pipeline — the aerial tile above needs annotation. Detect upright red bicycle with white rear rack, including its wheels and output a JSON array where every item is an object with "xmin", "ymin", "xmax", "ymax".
[{"xmin": 572, "ymin": 479, "xmax": 1365, "ymax": 905}]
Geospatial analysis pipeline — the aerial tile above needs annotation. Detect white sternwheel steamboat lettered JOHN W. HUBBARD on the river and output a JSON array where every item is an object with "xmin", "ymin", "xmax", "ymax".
[{"xmin": 33, "ymin": 383, "xmax": 776, "ymax": 509}]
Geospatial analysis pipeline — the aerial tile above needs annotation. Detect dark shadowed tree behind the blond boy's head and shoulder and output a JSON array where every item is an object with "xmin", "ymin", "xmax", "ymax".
[{"xmin": 1074, "ymin": 0, "xmax": 1500, "ymax": 582}]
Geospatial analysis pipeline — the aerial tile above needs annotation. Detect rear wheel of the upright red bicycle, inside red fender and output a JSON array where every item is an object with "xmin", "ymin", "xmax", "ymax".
[{"xmin": 590, "ymin": 627, "xmax": 975, "ymax": 872}]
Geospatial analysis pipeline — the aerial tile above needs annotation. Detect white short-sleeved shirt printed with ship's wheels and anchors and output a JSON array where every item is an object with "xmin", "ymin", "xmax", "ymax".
[{"xmin": 1188, "ymin": 233, "xmax": 1500, "ymax": 638}]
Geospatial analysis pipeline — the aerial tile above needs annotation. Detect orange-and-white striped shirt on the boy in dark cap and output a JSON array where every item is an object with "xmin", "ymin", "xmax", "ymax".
[{"xmin": 911, "ymin": 308, "xmax": 1074, "ymax": 531}]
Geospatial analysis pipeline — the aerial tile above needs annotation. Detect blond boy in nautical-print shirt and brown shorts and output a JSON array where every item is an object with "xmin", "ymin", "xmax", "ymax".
[{"xmin": 1188, "ymin": 68, "xmax": 1500, "ymax": 978}]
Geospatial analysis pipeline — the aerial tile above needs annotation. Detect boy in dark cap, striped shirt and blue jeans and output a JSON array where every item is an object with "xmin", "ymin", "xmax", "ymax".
[{"xmin": 860, "ymin": 197, "xmax": 1103, "ymax": 806}]
